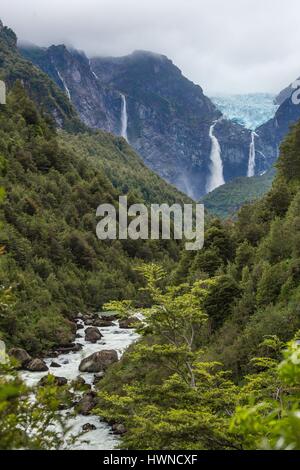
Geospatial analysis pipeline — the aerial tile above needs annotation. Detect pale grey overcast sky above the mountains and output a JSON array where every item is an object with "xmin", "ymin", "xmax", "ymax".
[{"xmin": 0, "ymin": 0, "xmax": 300, "ymax": 95}]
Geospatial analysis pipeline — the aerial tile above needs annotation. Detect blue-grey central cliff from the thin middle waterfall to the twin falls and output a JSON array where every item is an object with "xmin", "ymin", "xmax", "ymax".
[{"xmin": 91, "ymin": 51, "xmax": 255, "ymax": 198}]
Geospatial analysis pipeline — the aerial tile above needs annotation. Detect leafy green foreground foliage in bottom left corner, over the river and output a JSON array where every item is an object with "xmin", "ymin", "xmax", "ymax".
[{"xmin": 0, "ymin": 365, "xmax": 67, "ymax": 450}]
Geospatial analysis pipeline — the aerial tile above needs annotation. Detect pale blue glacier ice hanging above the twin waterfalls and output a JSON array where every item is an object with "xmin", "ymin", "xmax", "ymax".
[{"xmin": 211, "ymin": 93, "xmax": 278, "ymax": 130}]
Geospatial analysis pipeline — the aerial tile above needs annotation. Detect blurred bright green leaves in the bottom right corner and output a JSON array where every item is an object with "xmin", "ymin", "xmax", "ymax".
[{"xmin": 231, "ymin": 341, "xmax": 300, "ymax": 450}]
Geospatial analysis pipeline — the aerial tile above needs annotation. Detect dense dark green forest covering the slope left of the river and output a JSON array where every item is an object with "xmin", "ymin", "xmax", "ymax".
[{"xmin": 0, "ymin": 82, "xmax": 188, "ymax": 353}]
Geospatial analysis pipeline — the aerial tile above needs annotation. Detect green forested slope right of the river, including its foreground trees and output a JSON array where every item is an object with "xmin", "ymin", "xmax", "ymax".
[{"xmin": 95, "ymin": 119, "xmax": 300, "ymax": 449}]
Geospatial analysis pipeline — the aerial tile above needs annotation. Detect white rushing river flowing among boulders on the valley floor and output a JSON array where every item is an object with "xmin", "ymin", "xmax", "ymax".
[{"xmin": 21, "ymin": 322, "xmax": 139, "ymax": 450}]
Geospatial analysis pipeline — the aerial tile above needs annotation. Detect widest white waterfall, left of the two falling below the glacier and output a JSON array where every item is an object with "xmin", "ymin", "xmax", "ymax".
[{"xmin": 206, "ymin": 121, "xmax": 225, "ymax": 193}]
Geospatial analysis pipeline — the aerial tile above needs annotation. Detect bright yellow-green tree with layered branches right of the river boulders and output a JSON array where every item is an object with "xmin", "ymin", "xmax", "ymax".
[{"xmin": 104, "ymin": 264, "xmax": 214, "ymax": 387}]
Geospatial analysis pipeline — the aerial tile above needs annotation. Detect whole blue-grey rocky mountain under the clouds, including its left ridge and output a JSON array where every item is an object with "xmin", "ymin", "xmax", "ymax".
[{"xmin": 20, "ymin": 46, "xmax": 251, "ymax": 199}]
